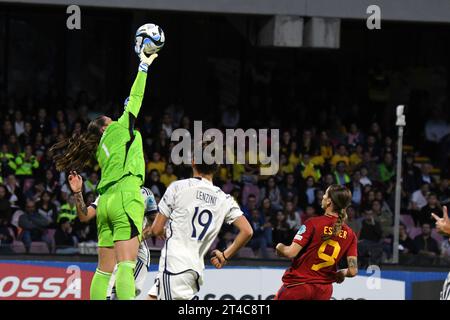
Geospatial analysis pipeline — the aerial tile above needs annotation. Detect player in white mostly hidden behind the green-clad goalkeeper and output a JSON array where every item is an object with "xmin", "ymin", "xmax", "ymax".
[{"xmin": 68, "ymin": 171, "xmax": 158, "ymax": 300}]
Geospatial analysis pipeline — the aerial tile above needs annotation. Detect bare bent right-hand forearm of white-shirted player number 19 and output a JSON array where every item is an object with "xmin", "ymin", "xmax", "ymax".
[{"xmin": 211, "ymin": 215, "xmax": 253, "ymax": 269}]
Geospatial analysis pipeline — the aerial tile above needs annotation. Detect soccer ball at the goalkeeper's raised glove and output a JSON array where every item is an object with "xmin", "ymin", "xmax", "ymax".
[{"xmin": 134, "ymin": 23, "xmax": 166, "ymax": 56}]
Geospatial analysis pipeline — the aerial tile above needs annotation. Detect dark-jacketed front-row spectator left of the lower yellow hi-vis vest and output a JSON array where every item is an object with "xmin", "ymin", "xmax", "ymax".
[{"xmin": 19, "ymin": 200, "xmax": 52, "ymax": 253}]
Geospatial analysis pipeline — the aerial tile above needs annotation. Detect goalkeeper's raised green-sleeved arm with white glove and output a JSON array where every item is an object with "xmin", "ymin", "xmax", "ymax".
[{"xmin": 118, "ymin": 52, "xmax": 158, "ymax": 129}]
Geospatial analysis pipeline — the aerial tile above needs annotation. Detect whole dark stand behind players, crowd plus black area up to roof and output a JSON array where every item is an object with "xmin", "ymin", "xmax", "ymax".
[{"xmin": 0, "ymin": 7, "xmax": 450, "ymax": 265}]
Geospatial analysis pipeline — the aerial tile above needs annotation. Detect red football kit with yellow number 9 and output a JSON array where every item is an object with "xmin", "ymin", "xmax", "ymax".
[{"xmin": 275, "ymin": 215, "xmax": 358, "ymax": 300}]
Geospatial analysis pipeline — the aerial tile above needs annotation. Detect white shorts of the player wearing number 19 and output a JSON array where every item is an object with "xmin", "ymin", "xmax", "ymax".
[{"xmin": 148, "ymin": 270, "xmax": 200, "ymax": 300}]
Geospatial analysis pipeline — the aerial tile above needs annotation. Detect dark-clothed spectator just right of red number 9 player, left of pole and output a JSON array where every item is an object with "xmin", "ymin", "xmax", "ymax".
[{"xmin": 358, "ymin": 210, "xmax": 383, "ymax": 266}]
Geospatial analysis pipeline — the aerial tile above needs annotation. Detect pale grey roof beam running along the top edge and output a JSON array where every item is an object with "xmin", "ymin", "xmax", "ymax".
[{"xmin": 0, "ymin": 0, "xmax": 450, "ymax": 23}]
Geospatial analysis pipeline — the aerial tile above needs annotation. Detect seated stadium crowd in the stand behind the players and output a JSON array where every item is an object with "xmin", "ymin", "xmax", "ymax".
[{"xmin": 0, "ymin": 95, "xmax": 450, "ymax": 265}]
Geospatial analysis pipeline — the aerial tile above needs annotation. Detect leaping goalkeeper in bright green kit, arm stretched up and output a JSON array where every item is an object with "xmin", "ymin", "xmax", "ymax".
[{"xmin": 52, "ymin": 50, "xmax": 158, "ymax": 300}]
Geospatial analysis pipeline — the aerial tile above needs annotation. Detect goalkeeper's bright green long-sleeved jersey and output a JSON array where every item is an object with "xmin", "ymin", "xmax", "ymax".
[{"xmin": 96, "ymin": 71, "xmax": 147, "ymax": 194}]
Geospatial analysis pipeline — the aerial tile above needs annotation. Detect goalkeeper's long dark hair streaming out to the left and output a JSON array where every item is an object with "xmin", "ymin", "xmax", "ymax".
[{"xmin": 50, "ymin": 116, "xmax": 106, "ymax": 172}]
